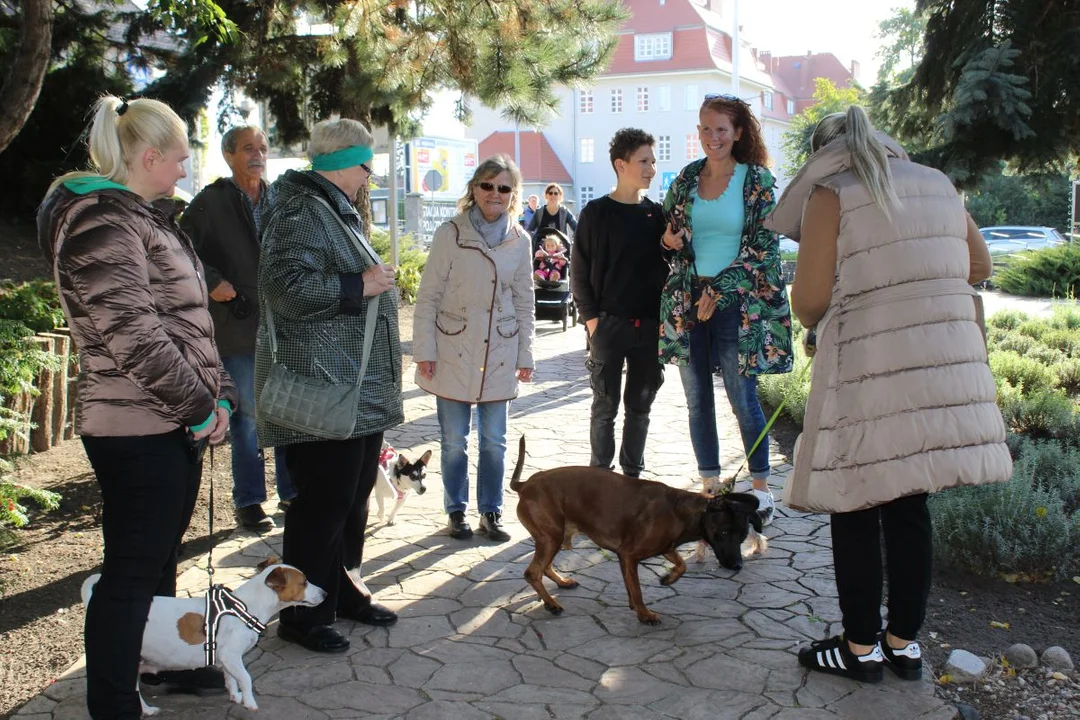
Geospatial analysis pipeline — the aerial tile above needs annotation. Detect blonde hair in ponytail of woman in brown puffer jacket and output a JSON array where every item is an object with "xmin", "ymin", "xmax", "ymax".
[{"xmin": 45, "ymin": 95, "xmax": 188, "ymax": 198}]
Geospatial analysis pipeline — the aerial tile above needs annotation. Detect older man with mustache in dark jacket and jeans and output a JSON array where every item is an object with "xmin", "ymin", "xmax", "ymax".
[{"xmin": 180, "ymin": 125, "xmax": 296, "ymax": 531}]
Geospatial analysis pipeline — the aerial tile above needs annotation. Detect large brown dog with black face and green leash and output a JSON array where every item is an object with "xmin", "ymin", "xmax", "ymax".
[{"xmin": 510, "ymin": 436, "xmax": 761, "ymax": 625}]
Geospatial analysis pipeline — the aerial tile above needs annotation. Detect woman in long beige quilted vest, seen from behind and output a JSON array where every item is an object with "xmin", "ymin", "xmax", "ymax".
[{"xmin": 766, "ymin": 107, "xmax": 1012, "ymax": 682}]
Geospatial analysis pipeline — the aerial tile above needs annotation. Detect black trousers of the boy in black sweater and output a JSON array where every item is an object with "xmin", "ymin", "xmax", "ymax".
[{"xmin": 585, "ymin": 313, "xmax": 664, "ymax": 477}]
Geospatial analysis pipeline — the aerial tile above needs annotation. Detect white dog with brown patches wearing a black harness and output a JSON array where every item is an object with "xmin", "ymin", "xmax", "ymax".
[{"xmin": 82, "ymin": 558, "xmax": 326, "ymax": 716}]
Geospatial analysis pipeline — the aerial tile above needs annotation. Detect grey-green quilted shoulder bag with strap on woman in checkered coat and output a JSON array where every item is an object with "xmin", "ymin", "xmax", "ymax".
[{"xmin": 255, "ymin": 198, "xmax": 381, "ymax": 440}]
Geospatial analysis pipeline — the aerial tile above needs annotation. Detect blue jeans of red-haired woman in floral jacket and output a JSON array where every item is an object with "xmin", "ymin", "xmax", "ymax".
[{"xmin": 679, "ymin": 303, "xmax": 769, "ymax": 480}]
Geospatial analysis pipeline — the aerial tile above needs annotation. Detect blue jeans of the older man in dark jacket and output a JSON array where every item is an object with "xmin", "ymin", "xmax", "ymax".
[{"xmin": 221, "ymin": 355, "xmax": 296, "ymax": 507}]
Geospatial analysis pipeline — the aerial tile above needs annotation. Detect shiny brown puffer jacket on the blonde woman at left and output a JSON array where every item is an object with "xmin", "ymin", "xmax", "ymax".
[{"xmin": 38, "ymin": 186, "xmax": 237, "ymax": 436}]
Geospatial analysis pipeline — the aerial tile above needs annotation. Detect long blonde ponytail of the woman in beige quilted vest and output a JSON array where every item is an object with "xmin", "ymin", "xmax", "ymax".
[{"xmin": 810, "ymin": 105, "xmax": 902, "ymax": 219}]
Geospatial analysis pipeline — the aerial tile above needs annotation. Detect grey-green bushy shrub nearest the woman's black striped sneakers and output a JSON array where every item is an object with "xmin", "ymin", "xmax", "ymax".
[{"xmin": 930, "ymin": 446, "xmax": 1080, "ymax": 579}]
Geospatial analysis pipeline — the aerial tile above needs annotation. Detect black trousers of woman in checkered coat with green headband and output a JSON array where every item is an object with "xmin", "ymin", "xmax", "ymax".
[{"xmin": 279, "ymin": 433, "xmax": 382, "ymax": 633}]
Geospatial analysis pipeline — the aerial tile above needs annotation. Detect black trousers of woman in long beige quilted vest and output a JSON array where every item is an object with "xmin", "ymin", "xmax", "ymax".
[{"xmin": 832, "ymin": 493, "xmax": 933, "ymax": 646}]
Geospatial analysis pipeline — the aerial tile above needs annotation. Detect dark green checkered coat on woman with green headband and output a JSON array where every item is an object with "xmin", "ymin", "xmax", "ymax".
[{"xmin": 255, "ymin": 171, "xmax": 405, "ymax": 448}]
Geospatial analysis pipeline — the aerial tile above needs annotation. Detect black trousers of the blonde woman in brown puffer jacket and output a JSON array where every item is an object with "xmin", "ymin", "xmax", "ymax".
[{"xmin": 82, "ymin": 430, "xmax": 202, "ymax": 720}]
